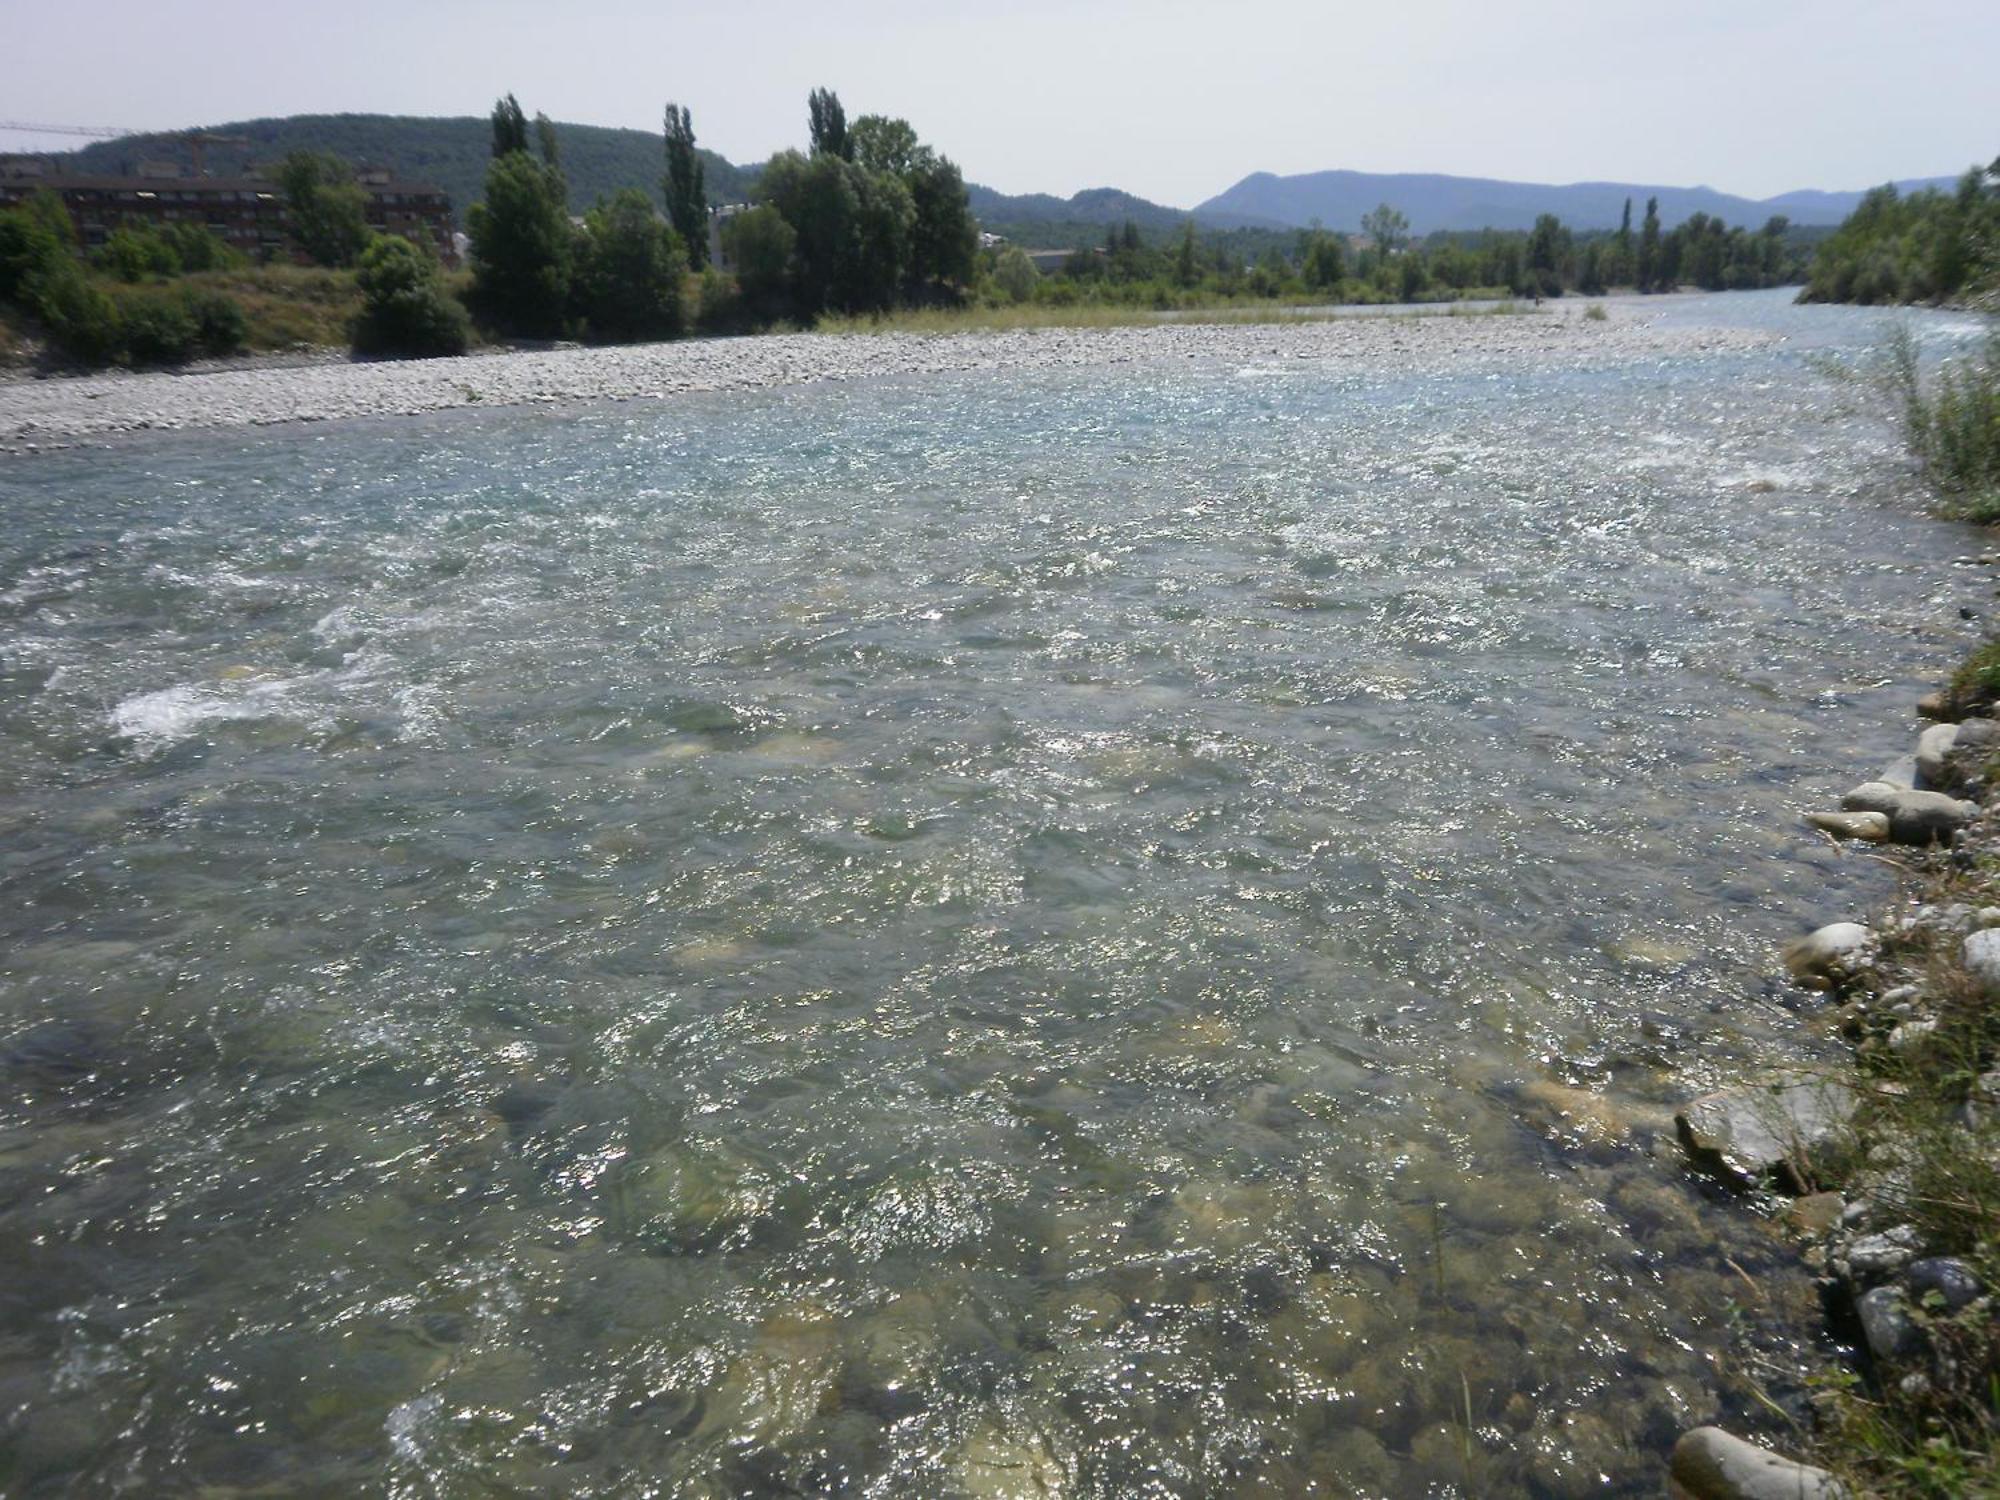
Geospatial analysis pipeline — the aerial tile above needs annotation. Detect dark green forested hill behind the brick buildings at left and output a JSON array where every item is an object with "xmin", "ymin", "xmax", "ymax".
[{"xmin": 62, "ymin": 114, "xmax": 756, "ymax": 222}]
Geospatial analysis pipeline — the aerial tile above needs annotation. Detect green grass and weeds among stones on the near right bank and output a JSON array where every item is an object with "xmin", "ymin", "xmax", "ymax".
[{"xmin": 1812, "ymin": 788, "xmax": 2000, "ymax": 1500}]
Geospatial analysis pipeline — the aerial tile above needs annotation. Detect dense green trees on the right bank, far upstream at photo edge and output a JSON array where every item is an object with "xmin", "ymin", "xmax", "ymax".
[{"xmin": 1800, "ymin": 158, "xmax": 2000, "ymax": 304}]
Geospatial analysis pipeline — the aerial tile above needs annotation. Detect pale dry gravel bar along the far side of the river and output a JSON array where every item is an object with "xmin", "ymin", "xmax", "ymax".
[{"xmin": 0, "ymin": 308, "xmax": 1764, "ymax": 454}]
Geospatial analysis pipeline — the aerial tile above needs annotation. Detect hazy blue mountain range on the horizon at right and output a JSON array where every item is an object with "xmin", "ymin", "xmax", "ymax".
[{"xmin": 1194, "ymin": 172, "xmax": 1952, "ymax": 234}]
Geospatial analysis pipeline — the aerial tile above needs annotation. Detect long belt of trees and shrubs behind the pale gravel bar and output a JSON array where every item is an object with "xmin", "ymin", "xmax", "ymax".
[{"xmin": 0, "ymin": 90, "xmax": 1814, "ymax": 366}]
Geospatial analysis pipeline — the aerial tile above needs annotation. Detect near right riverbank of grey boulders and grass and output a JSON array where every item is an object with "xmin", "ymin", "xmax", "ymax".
[{"xmin": 1672, "ymin": 688, "xmax": 2000, "ymax": 1500}]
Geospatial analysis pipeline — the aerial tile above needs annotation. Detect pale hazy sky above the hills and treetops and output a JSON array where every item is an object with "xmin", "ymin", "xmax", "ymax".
[{"xmin": 0, "ymin": 0, "xmax": 2000, "ymax": 206}]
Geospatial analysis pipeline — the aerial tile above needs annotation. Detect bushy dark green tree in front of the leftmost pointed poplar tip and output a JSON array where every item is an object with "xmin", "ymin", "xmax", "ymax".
[{"xmin": 466, "ymin": 150, "xmax": 574, "ymax": 338}]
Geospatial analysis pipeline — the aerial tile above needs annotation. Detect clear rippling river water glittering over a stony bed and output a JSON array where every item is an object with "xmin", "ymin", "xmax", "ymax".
[{"xmin": 0, "ymin": 294, "xmax": 1986, "ymax": 1500}]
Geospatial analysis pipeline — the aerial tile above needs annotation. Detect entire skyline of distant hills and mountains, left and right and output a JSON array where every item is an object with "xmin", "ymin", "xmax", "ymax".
[{"xmin": 31, "ymin": 114, "xmax": 1952, "ymax": 248}]
